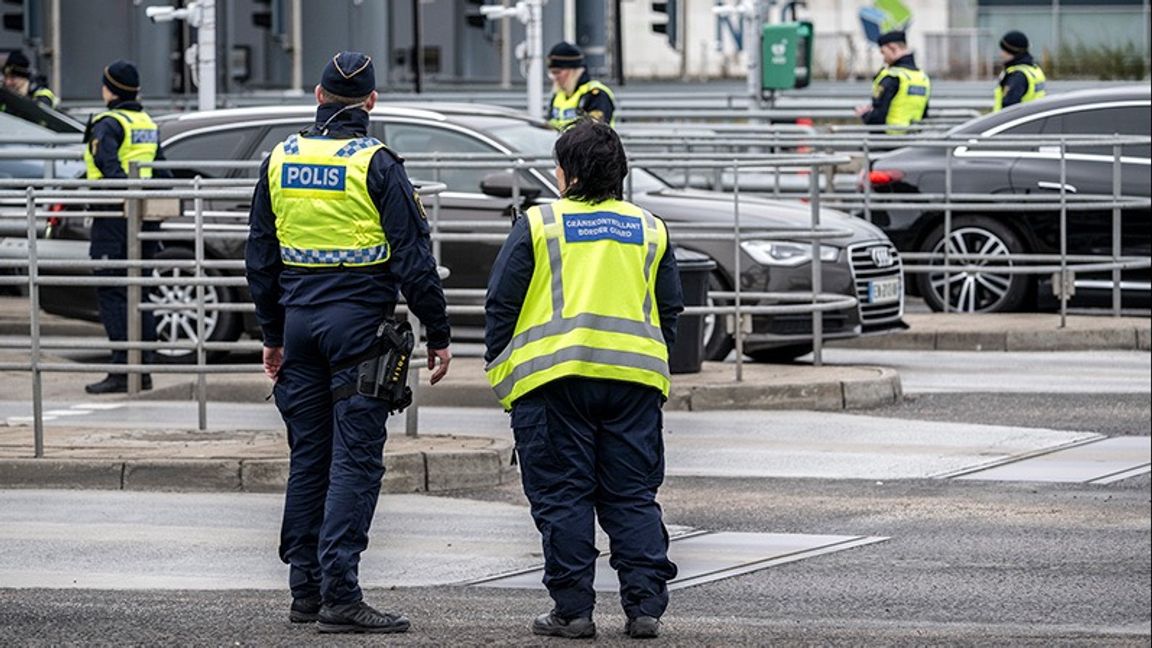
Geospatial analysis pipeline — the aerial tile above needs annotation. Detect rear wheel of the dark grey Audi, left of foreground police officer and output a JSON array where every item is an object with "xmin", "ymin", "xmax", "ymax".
[{"xmin": 149, "ymin": 248, "xmax": 242, "ymax": 364}]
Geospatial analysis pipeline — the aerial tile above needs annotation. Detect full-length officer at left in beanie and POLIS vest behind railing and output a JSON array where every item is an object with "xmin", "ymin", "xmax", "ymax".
[{"xmin": 84, "ymin": 60, "xmax": 172, "ymax": 394}]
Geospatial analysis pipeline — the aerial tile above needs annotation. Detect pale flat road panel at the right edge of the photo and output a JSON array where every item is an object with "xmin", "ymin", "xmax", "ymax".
[{"xmin": 950, "ymin": 437, "xmax": 1152, "ymax": 484}]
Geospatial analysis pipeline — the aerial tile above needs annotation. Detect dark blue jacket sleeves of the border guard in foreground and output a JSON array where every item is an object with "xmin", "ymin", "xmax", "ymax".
[{"xmin": 484, "ymin": 211, "xmax": 684, "ymax": 362}]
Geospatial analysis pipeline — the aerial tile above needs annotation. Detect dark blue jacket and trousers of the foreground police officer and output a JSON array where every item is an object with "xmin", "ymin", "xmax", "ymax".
[{"xmin": 245, "ymin": 78, "xmax": 449, "ymax": 608}]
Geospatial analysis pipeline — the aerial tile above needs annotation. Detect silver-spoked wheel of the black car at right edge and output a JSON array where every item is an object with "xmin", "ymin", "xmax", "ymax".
[{"xmin": 916, "ymin": 217, "xmax": 1031, "ymax": 312}]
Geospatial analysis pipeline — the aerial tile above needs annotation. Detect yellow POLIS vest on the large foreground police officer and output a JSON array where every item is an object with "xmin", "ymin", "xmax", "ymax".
[{"xmin": 268, "ymin": 135, "xmax": 392, "ymax": 268}]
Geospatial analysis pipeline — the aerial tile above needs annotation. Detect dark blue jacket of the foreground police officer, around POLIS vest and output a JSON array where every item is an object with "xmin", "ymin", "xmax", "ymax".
[{"xmin": 244, "ymin": 104, "xmax": 450, "ymax": 348}]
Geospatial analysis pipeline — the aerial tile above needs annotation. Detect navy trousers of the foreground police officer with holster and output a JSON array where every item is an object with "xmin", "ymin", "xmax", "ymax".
[{"xmin": 274, "ymin": 302, "xmax": 388, "ymax": 604}]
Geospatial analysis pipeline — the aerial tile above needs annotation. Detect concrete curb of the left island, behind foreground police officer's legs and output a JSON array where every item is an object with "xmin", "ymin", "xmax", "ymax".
[{"xmin": 0, "ymin": 439, "xmax": 517, "ymax": 493}]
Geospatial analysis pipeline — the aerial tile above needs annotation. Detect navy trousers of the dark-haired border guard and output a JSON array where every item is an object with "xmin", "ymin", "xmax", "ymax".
[{"xmin": 511, "ymin": 378, "xmax": 676, "ymax": 619}]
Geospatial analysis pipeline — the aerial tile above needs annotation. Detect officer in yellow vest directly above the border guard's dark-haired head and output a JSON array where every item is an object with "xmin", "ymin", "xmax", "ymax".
[{"xmin": 548, "ymin": 43, "xmax": 616, "ymax": 130}]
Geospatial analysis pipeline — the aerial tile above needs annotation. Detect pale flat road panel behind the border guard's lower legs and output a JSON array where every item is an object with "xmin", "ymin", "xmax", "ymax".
[{"xmin": 469, "ymin": 532, "xmax": 888, "ymax": 592}]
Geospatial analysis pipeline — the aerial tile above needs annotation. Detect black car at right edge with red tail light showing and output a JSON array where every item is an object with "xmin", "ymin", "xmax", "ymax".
[{"xmin": 870, "ymin": 85, "xmax": 1152, "ymax": 312}]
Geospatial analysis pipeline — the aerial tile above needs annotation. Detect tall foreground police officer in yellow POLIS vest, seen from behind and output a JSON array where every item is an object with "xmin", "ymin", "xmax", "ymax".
[{"xmin": 245, "ymin": 52, "xmax": 452, "ymax": 633}]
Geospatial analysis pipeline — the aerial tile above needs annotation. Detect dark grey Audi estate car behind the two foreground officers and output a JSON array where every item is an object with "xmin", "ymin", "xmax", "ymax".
[{"xmin": 15, "ymin": 104, "xmax": 903, "ymax": 361}]
